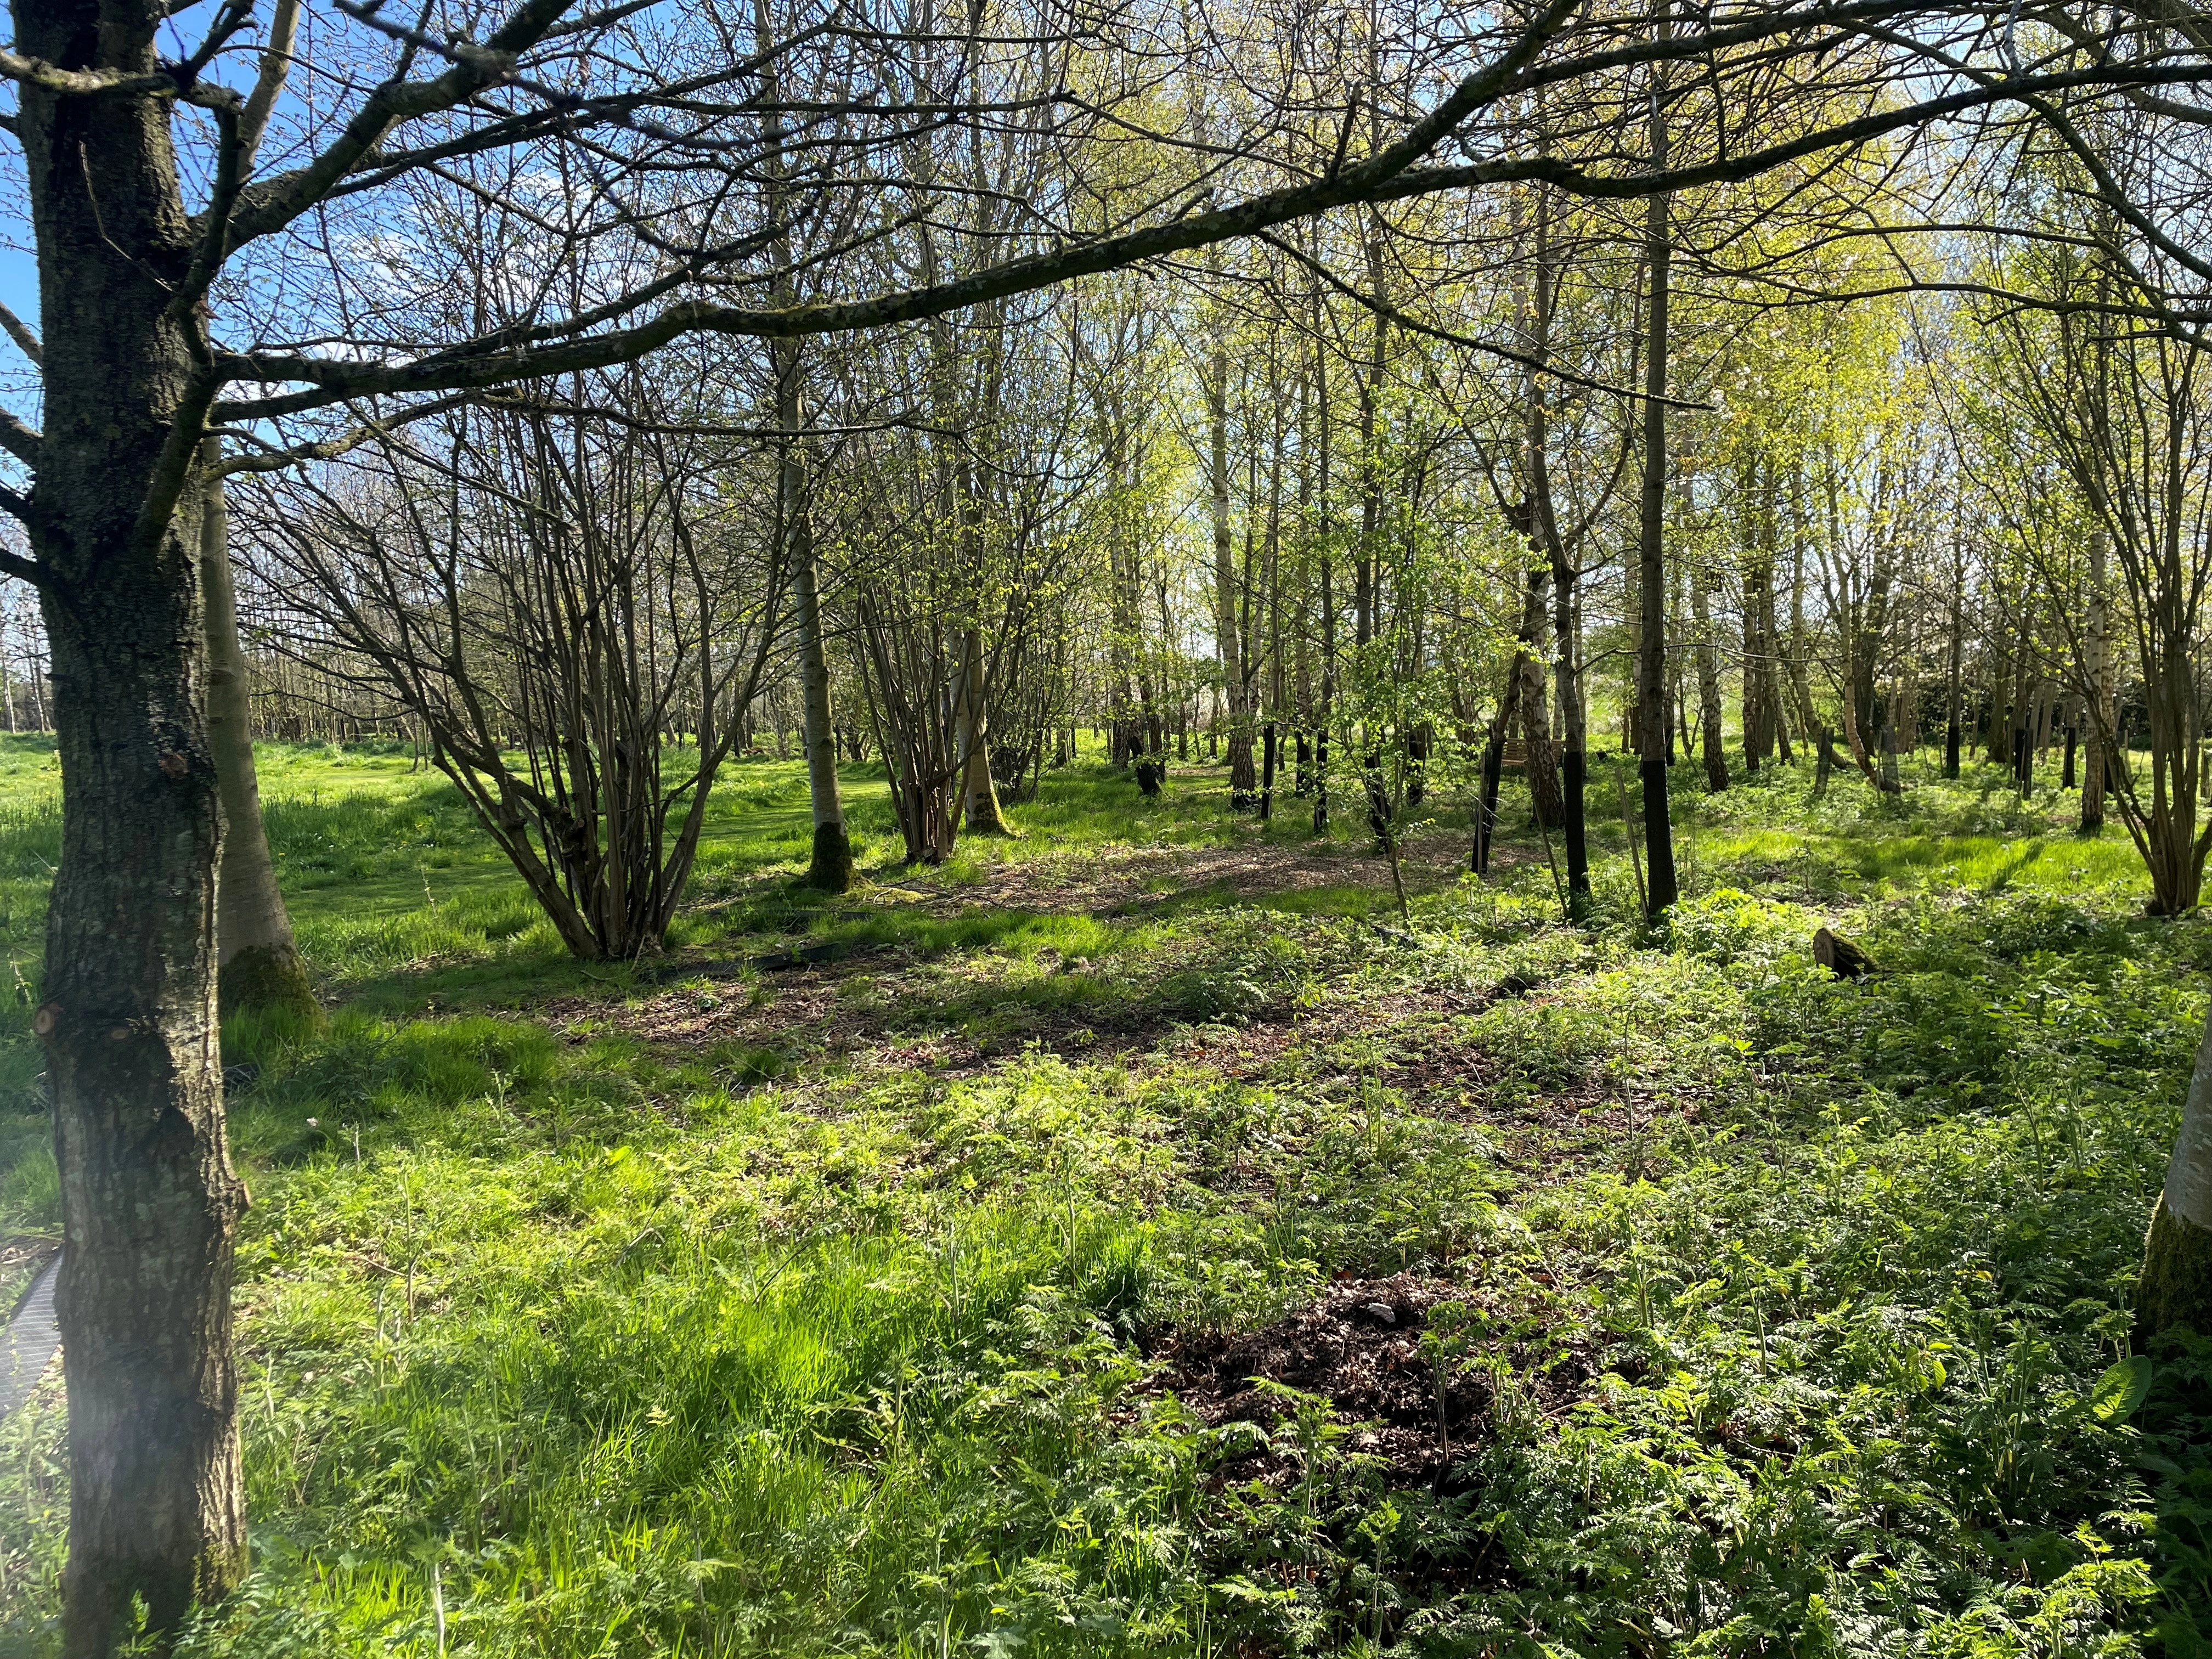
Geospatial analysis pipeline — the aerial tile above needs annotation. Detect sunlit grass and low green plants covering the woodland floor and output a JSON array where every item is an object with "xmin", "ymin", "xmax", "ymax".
[{"xmin": 0, "ymin": 739, "xmax": 2212, "ymax": 1659}]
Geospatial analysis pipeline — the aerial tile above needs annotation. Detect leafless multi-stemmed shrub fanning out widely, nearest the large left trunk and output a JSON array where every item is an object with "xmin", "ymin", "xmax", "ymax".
[{"xmin": 257, "ymin": 382, "xmax": 787, "ymax": 960}]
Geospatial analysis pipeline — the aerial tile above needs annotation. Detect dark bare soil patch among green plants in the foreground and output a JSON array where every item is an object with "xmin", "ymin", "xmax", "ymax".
[{"xmin": 1150, "ymin": 1274, "xmax": 1593, "ymax": 1491}]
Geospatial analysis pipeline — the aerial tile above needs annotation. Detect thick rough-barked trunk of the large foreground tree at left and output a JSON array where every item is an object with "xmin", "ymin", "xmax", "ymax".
[{"xmin": 15, "ymin": 16, "xmax": 246, "ymax": 1659}]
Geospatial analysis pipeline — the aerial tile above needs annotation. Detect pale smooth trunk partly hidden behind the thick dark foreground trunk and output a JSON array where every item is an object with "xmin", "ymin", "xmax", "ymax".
[{"xmin": 199, "ymin": 455, "xmax": 321, "ymax": 1020}]
